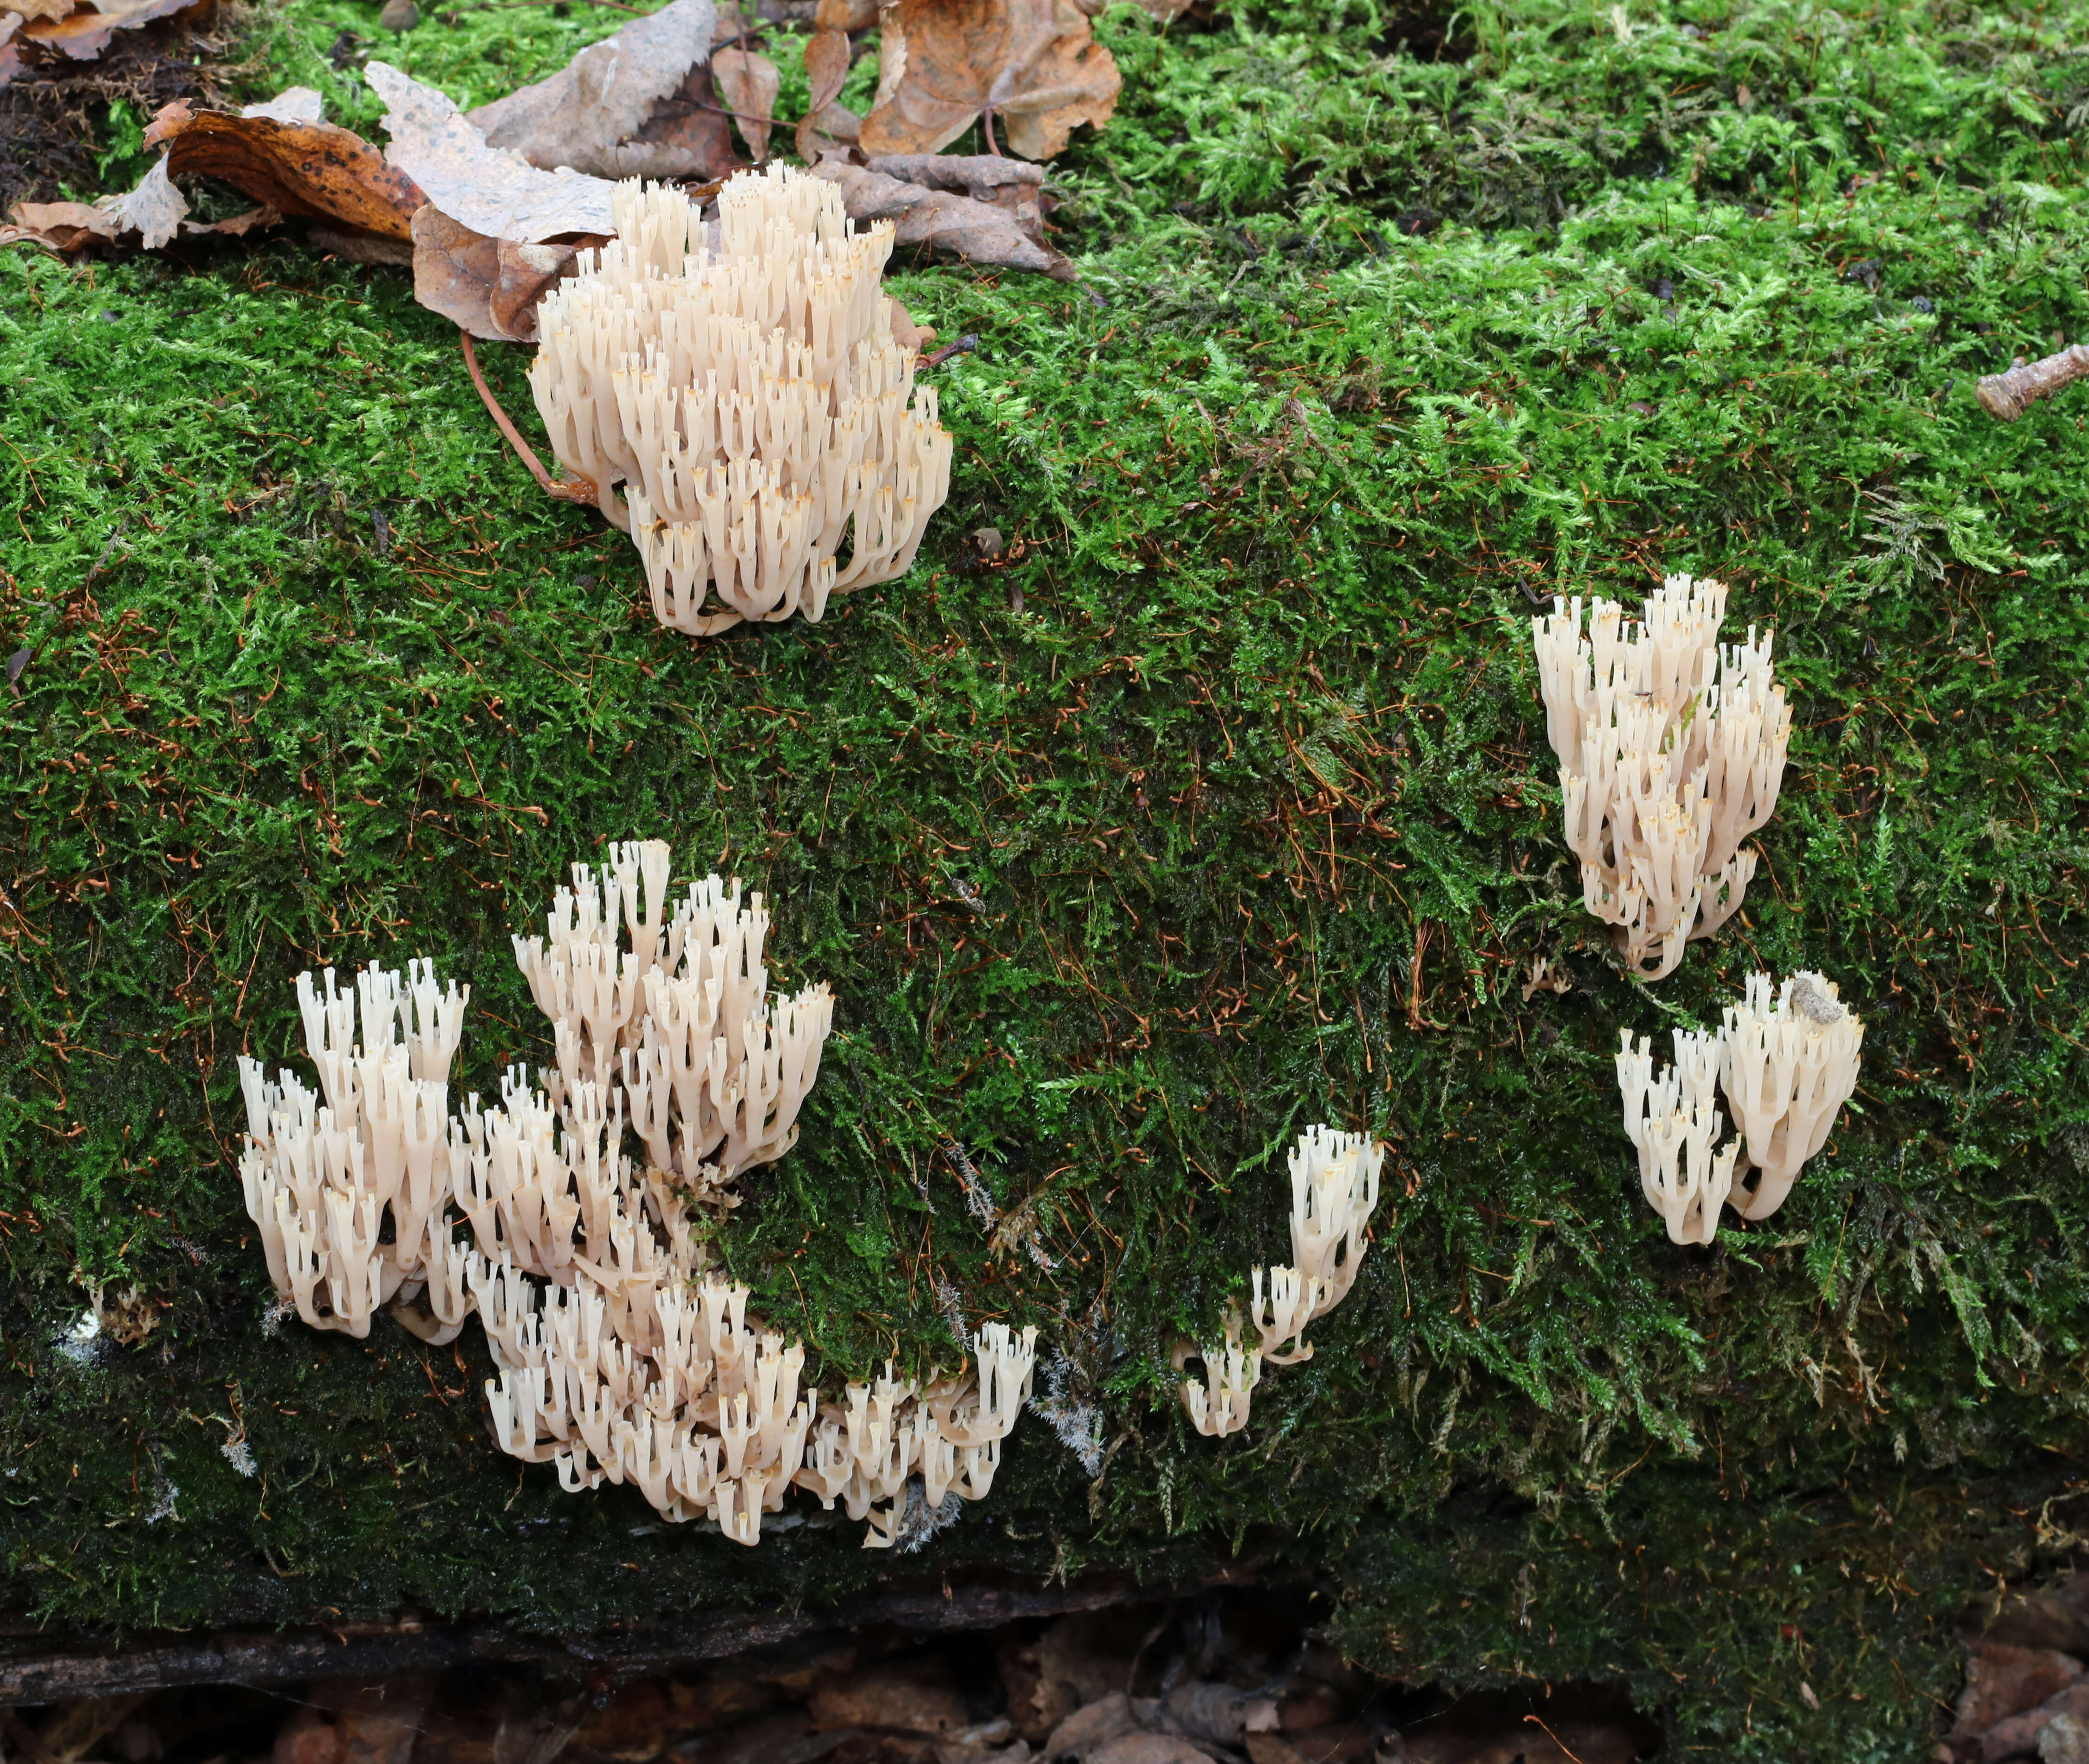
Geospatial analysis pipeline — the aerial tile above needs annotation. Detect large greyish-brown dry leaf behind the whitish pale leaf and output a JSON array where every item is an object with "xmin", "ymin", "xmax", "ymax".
[{"xmin": 468, "ymin": 0, "xmax": 744, "ymax": 184}]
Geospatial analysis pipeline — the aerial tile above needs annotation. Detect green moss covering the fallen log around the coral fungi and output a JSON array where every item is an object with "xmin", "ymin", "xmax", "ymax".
[{"xmin": 0, "ymin": 0, "xmax": 2089, "ymax": 1760}]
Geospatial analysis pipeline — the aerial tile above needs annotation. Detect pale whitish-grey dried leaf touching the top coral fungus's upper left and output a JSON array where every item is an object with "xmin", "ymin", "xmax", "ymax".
[{"xmin": 363, "ymin": 61, "xmax": 618, "ymax": 245}]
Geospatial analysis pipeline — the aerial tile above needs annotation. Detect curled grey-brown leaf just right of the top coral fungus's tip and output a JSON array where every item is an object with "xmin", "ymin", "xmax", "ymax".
[{"xmin": 813, "ymin": 155, "xmax": 1076, "ymax": 282}]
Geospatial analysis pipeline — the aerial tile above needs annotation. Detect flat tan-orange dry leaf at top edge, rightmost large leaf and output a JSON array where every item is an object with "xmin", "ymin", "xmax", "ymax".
[{"xmin": 863, "ymin": 0, "xmax": 1124, "ymax": 159}]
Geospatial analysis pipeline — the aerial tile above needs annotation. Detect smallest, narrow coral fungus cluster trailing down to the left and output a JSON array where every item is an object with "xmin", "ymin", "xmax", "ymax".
[{"xmin": 1174, "ymin": 1127, "xmax": 1385, "ymax": 1440}]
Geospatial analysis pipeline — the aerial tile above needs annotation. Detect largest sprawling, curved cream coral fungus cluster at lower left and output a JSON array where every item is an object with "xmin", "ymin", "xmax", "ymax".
[{"xmin": 240, "ymin": 840, "xmax": 1036, "ymax": 1547}]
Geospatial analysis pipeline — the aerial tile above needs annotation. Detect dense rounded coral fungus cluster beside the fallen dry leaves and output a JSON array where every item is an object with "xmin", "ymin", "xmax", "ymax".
[{"xmin": 529, "ymin": 165, "xmax": 953, "ymax": 636}]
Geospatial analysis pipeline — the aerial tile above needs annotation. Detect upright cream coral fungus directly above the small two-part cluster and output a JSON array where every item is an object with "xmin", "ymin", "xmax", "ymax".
[{"xmin": 1531, "ymin": 575, "xmax": 1792, "ymax": 980}]
